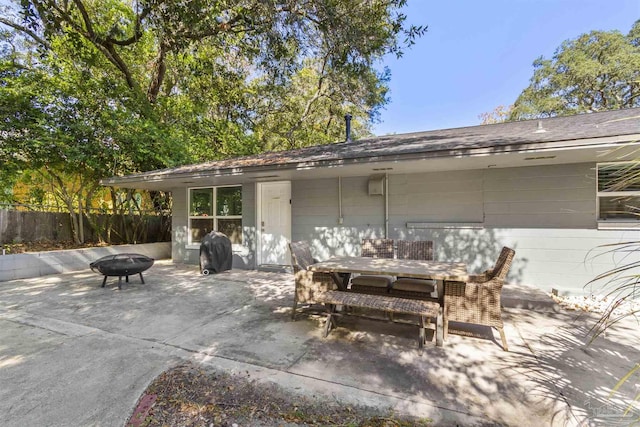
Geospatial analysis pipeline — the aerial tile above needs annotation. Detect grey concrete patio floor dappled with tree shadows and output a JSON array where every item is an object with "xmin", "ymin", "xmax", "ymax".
[{"xmin": 0, "ymin": 261, "xmax": 640, "ymax": 426}]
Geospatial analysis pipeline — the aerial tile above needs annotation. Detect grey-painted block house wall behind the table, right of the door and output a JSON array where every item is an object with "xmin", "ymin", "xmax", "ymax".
[{"xmin": 292, "ymin": 163, "xmax": 640, "ymax": 294}]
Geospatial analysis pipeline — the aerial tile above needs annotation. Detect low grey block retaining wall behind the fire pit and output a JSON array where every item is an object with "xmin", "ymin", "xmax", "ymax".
[{"xmin": 0, "ymin": 242, "xmax": 171, "ymax": 282}]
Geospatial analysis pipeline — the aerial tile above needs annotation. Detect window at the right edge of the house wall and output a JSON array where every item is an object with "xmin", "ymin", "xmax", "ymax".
[{"xmin": 597, "ymin": 162, "xmax": 640, "ymax": 222}]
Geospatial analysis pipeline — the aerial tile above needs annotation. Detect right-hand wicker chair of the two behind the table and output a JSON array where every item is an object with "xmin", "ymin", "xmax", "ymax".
[{"xmin": 389, "ymin": 240, "xmax": 442, "ymax": 300}]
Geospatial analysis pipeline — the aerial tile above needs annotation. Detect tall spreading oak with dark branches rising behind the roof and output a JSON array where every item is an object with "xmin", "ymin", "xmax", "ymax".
[{"xmin": 5, "ymin": 0, "xmax": 426, "ymax": 161}]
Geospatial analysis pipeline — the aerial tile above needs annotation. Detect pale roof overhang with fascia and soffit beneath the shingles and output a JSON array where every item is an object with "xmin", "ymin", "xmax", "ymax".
[{"xmin": 101, "ymin": 134, "xmax": 640, "ymax": 191}]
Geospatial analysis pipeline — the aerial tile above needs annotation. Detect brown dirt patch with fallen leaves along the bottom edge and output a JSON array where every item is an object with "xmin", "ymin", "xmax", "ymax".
[{"xmin": 127, "ymin": 364, "xmax": 433, "ymax": 427}]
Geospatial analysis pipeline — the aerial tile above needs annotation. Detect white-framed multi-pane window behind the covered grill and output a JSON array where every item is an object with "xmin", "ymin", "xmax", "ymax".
[{"xmin": 189, "ymin": 186, "xmax": 242, "ymax": 244}]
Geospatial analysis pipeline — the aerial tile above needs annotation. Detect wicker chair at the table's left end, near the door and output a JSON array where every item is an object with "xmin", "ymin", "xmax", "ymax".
[{"xmin": 289, "ymin": 241, "xmax": 337, "ymax": 320}]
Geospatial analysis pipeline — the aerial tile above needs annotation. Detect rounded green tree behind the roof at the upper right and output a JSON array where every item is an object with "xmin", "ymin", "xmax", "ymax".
[{"xmin": 509, "ymin": 20, "xmax": 640, "ymax": 120}]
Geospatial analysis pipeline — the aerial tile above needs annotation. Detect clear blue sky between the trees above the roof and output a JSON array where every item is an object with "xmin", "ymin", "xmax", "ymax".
[{"xmin": 373, "ymin": 0, "xmax": 640, "ymax": 135}]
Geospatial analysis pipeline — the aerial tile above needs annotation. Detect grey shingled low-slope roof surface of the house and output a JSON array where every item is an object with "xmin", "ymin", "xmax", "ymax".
[{"xmin": 102, "ymin": 108, "xmax": 640, "ymax": 185}]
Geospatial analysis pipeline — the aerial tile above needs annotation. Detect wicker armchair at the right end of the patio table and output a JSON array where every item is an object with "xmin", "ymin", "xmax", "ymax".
[{"xmin": 444, "ymin": 247, "xmax": 515, "ymax": 351}]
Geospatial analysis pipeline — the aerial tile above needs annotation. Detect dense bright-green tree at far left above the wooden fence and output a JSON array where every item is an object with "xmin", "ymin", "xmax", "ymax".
[{"xmin": 0, "ymin": 15, "xmax": 181, "ymax": 243}]
